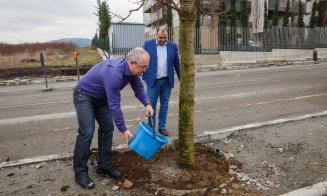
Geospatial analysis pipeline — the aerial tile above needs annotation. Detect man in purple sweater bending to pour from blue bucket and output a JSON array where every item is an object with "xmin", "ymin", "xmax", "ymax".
[{"xmin": 73, "ymin": 48, "xmax": 153, "ymax": 189}]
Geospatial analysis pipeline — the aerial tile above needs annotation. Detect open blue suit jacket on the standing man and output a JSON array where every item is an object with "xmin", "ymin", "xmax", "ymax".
[{"xmin": 143, "ymin": 39, "xmax": 180, "ymax": 88}]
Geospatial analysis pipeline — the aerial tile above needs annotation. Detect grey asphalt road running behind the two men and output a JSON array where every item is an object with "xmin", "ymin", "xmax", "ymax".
[{"xmin": 0, "ymin": 64, "xmax": 327, "ymax": 160}]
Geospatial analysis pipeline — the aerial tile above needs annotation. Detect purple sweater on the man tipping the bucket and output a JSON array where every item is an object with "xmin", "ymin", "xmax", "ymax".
[{"xmin": 78, "ymin": 58, "xmax": 150, "ymax": 132}]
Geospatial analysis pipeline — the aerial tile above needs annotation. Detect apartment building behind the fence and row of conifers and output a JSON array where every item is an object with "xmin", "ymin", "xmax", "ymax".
[{"xmin": 143, "ymin": 0, "xmax": 327, "ymax": 53}]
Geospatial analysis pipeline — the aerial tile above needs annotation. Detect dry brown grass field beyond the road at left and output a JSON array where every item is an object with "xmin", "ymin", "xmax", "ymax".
[{"xmin": 0, "ymin": 43, "xmax": 102, "ymax": 70}]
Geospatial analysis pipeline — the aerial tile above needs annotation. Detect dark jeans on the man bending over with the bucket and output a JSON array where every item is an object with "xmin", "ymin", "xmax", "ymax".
[{"xmin": 73, "ymin": 87, "xmax": 114, "ymax": 177}]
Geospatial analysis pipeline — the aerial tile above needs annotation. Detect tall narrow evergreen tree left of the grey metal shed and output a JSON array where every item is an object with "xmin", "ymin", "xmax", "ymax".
[{"xmin": 95, "ymin": 0, "xmax": 111, "ymax": 39}]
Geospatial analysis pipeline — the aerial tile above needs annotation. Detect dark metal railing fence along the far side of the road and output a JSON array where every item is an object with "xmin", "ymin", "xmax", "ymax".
[{"xmin": 145, "ymin": 25, "xmax": 327, "ymax": 54}]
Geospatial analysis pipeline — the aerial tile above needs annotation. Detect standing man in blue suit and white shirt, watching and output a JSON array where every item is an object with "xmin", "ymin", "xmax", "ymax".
[{"xmin": 143, "ymin": 26, "xmax": 180, "ymax": 136}]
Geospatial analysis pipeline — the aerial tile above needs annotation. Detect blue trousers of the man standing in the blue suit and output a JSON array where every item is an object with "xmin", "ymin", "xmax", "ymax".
[{"xmin": 147, "ymin": 78, "xmax": 171, "ymax": 129}]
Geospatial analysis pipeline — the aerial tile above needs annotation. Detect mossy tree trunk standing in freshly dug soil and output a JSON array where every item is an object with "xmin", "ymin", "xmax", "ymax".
[{"xmin": 177, "ymin": 0, "xmax": 195, "ymax": 169}]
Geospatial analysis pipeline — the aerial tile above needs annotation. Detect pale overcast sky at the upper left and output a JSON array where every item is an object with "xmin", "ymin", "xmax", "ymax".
[{"xmin": 0, "ymin": 0, "xmax": 143, "ymax": 44}]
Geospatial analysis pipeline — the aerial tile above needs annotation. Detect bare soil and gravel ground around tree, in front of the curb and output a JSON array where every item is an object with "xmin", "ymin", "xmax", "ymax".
[{"xmin": 0, "ymin": 116, "xmax": 327, "ymax": 196}]
